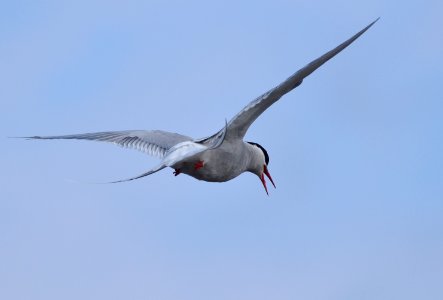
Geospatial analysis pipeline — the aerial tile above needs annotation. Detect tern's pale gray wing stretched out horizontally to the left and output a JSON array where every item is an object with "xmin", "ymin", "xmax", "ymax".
[{"xmin": 26, "ymin": 130, "xmax": 192, "ymax": 158}]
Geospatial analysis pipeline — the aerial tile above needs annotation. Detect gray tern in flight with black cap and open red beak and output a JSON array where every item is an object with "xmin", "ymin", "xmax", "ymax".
[{"xmin": 22, "ymin": 18, "xmax": 379, "ymax": 195}]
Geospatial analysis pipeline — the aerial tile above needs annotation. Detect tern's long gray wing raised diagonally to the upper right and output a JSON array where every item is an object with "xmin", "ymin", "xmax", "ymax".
[{"xmin": 226, "ymin": 19, "xmax": 378, "ymax": 139}]
